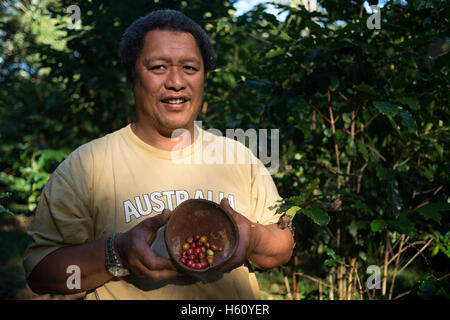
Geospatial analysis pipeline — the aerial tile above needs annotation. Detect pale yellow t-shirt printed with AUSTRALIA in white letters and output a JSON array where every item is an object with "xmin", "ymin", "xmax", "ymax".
[{"xmin": 24, "ymin": 125, "xmax": 280, "ymax": 300}]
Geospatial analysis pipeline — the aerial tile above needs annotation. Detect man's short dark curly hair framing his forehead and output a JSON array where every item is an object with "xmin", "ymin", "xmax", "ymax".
[{"xmin": 120, "ymin": 9, "xmax": 214, "ymax": 86}]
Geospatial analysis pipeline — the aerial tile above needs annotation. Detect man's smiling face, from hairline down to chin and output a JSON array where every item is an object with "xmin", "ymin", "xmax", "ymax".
[{"xmin": 133, "ymin": 30, "xmax": 204, "ymax": 136}]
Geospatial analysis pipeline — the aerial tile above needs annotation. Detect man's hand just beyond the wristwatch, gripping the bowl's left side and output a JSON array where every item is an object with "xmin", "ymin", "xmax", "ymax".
[{"xmin": 116, "ymin": 209, "xmax": 179, "ymax": 281}]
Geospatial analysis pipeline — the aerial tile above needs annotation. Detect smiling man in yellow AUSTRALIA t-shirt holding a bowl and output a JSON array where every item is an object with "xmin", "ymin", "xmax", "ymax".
[{"xmin": 24, "ymin": 10, "xmax": 293, "ymax": 299}]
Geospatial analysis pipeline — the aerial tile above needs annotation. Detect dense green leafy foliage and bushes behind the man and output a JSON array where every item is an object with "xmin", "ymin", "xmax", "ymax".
[{"xmin": 0, "ymin": 0, "xmax": 450, "ymax": 299}]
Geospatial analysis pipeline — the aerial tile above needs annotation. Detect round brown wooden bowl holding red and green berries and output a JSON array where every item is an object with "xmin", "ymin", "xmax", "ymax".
[{"xmin": 164, "ymin": 199, "xmax": 239, "ymax": 273}]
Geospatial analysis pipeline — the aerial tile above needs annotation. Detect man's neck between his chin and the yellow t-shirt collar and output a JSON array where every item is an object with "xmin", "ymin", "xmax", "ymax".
[{"xmin": 131, "ymin": 122, "xmax": 195, "ymax": 151}]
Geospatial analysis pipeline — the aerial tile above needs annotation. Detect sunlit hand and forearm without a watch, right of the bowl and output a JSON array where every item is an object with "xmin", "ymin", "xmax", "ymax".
[{"xmin": 218, "ymin": 198, "xmax": 294, "ymax": 272}]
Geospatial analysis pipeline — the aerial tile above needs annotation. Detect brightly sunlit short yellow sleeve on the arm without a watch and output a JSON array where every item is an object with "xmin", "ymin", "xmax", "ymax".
[{"xmin": 246, "ymin": 152, "xmax": 282, "ymax": 225}]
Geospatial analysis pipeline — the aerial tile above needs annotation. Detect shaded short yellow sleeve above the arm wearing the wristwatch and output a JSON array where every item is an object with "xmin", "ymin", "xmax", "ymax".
[{"xmin": 23, "ymin": 146, "xmax": 94, "ymax": 277}]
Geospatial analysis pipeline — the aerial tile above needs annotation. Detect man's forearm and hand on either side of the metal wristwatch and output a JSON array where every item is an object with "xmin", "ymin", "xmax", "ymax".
[{"xmin": 27, "ymin": 210, "xmax": 178, "ymax": 294}]
